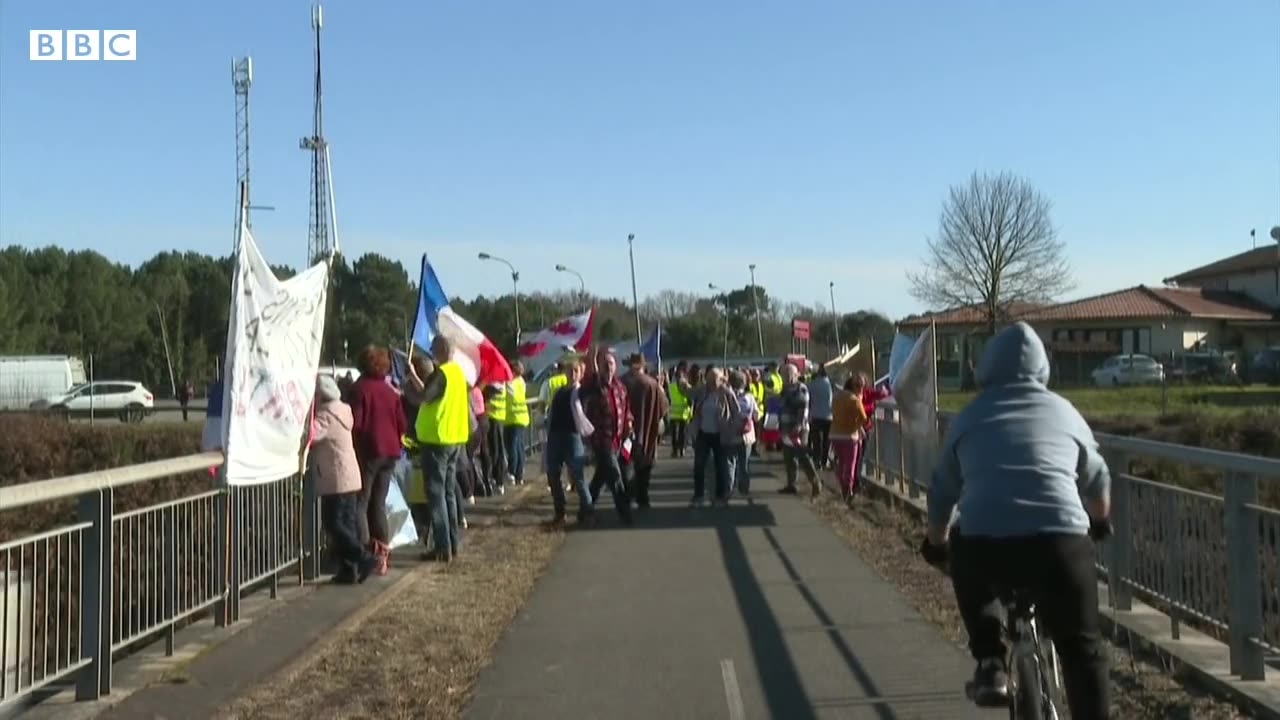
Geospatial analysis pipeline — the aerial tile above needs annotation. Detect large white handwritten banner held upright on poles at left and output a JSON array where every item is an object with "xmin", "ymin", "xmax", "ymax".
[{"xmin": 223, "ymin": 221, "xmax": 329, "ymax": 486}]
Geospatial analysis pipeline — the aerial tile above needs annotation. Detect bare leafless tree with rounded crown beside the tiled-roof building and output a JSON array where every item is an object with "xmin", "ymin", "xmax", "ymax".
[{"xmin": 906, "ymin": 173, "xmax": 1075, "ymax": 333}]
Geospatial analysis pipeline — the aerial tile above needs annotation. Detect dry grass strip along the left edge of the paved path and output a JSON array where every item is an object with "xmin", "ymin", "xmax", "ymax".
[{"xmin": 228, "ymin": 488, "xmax": 563, "ymax": 720}]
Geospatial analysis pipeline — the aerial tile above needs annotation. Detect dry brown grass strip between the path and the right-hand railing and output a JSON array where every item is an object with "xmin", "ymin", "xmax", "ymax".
[{"xmin": 815, "ymin": 484, "xmax": 1252, "ymax": 720}]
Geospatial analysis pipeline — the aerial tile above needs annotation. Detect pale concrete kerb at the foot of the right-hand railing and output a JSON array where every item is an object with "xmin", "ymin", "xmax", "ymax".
[{"xmin": 859, "ymin": 475, "xmax": 1280, "ymax": 720}]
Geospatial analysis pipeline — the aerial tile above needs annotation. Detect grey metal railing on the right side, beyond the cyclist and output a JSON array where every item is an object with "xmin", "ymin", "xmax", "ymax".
[{"xmin": 865, "ymin": 401, "xmax": 1280, "ymax": 680}]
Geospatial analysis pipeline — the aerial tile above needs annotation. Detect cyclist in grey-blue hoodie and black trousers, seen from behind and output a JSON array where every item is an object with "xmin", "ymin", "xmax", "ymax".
[{"xmin": 924, "ymin": 323, "xmax": 1111, "ymax": 720}]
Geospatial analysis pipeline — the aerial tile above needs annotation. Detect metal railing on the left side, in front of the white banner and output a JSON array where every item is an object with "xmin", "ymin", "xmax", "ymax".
[{"xmin": 0, "ymin": 411, "xmax": 545, "ymax": 716}]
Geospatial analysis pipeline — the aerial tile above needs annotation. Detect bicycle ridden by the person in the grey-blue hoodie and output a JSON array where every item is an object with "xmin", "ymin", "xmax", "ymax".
[{"xmin": 922, "ymin": 520, "xmax": 1112, "ymax": 720}]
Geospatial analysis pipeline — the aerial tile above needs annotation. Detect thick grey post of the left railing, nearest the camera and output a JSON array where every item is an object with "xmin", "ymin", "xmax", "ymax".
[{"xmin": 76, "ymin": 489, "xmax": 111, "ymax": 700}]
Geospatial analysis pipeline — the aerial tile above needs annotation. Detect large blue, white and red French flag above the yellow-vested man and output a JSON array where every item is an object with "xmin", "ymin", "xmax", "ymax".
[{"xmin": 413, "ymin": 255, "xmax": 513, "ymax": 386}]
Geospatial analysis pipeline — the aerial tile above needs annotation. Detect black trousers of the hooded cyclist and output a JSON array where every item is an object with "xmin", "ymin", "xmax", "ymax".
[{"xmin": 951, "ymin": 533, "xmax": 1110, "ymax": 720}]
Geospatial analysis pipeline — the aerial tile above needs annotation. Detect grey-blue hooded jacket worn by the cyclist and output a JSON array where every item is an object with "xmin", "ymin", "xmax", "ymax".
[{"xmin": 928, "ymin": 323, "xmax": 1111, "ymax": 538}]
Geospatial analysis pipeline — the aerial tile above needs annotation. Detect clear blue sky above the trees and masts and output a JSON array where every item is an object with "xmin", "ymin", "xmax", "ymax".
[{"xmin": 0, "ymin": 0, "xmax": 1280, "ymax": 315}]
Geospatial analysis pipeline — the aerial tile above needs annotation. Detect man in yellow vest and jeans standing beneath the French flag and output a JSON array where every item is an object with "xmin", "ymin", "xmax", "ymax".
[{"xmin": 411, "ymin": 334, "xmax": 471, "ymax": 562}]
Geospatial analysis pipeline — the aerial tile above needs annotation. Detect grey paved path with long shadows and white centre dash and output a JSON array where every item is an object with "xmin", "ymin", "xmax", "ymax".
[{"xmin": 468, "ymin": 460, "xmax": 1005, "ymax": 720}]
